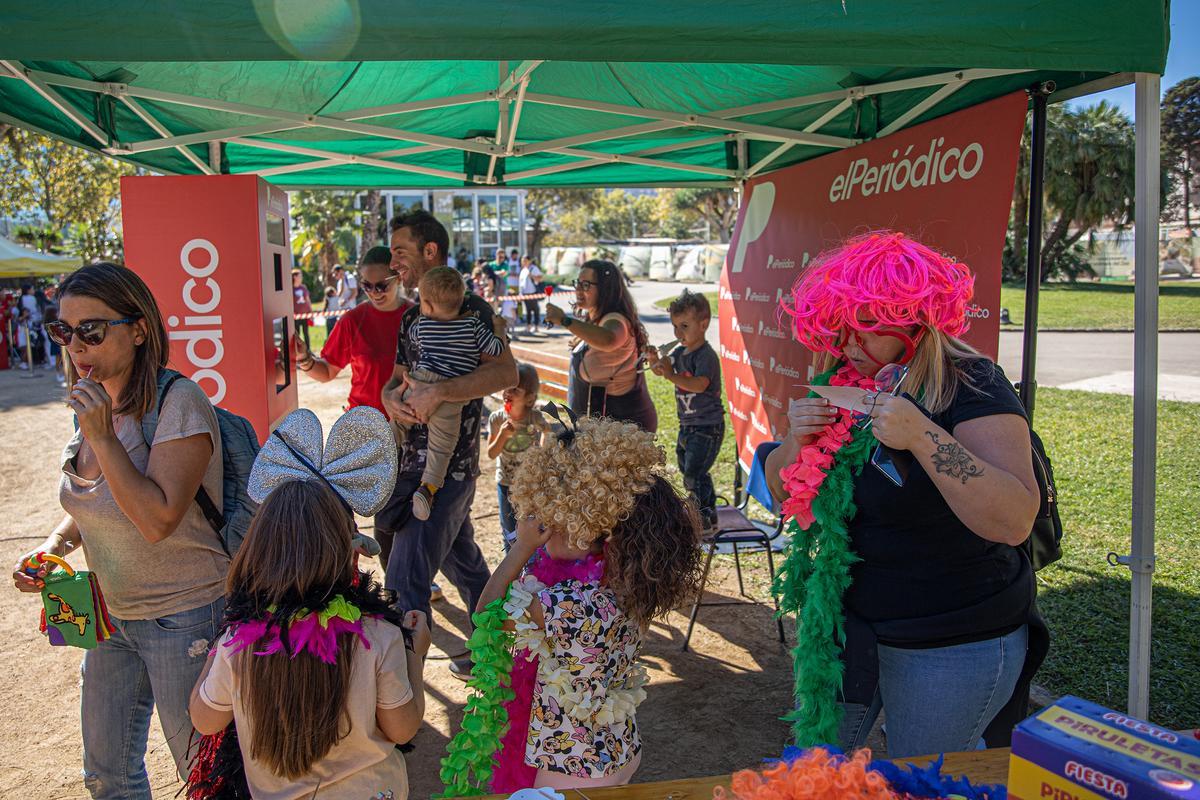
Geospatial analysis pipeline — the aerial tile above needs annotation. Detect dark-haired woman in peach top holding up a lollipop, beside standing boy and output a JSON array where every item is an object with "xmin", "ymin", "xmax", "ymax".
[{"xmin": 546, "ymin": 259, "xmax": 659, "ymax": 433}]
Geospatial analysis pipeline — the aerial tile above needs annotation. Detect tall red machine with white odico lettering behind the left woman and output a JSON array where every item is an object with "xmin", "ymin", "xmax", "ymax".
[{"xmin": 121, "ymin": 175, "xmax": 296, "ymax": 441}]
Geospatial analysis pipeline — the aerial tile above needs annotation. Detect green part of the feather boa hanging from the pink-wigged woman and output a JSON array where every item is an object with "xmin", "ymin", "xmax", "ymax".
[{"xmin": 773, "ymin": 365, "xmax": 875, "ymax": 747}]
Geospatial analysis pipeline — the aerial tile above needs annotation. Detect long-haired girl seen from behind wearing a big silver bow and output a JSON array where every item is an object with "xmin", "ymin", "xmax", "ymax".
[{"xmin": 188, "ymin": 407, "xmax": 430, "ymax": 800}]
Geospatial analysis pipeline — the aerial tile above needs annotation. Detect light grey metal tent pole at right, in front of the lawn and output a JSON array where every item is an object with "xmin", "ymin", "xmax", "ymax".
[{"xmin": 1124, "ymin": 72, "xmax": 1162, "ymax": 720}]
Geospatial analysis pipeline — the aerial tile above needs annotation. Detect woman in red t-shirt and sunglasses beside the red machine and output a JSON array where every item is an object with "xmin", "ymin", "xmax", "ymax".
[{"xmin": 296, "ymin": 247, "xmax": 412, "ymax": 567}]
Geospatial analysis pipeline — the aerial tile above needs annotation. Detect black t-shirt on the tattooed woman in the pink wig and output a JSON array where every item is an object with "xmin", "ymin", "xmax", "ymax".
[{"xmin": 845, "ymin": 359, "xmax": 1034, "ymax": 648}]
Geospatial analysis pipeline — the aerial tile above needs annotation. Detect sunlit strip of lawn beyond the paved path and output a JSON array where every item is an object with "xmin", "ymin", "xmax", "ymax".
[{"xmin": 654, "ymin": 283, "xmax": 1200, "ymax": 331}]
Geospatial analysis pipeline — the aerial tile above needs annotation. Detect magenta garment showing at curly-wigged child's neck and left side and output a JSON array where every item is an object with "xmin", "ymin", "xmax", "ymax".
[{"xmin": 492, "ymin": 549, "xmax": 604, "ymax": 793}]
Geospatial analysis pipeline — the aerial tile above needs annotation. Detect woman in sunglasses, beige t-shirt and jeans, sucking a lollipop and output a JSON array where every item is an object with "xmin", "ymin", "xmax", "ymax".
[{"xmin": 13, "ymin": 264, "xmax": 229, "ymax": 800}]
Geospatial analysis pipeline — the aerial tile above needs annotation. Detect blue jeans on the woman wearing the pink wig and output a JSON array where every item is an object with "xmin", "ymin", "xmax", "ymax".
[{"xmin": 838, "ymin": 625, "xmax": 1030, "ymax": 758}]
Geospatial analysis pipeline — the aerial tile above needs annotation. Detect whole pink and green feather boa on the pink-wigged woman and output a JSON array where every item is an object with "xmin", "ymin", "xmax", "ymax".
[{"xmin": 774, "ymin": 365, "xmax": 875, "ymax": 747}]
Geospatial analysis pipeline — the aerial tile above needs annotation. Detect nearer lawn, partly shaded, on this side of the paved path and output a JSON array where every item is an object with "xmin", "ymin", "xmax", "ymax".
[{"xmin": 649, "ymin": 375, "xmax": 1200, "ymax": 729}]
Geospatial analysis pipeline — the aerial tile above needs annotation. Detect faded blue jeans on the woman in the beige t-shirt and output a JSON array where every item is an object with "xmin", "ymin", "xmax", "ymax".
[{"xmin": 80, "ymin": 597, "xmax": 224, "ymax": 800}]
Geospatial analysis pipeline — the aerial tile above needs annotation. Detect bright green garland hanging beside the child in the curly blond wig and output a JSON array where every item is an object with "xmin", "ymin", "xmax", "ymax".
[{"xmin": 437, "ymin": 593, "xmax": 514, "ymax": 798}]
